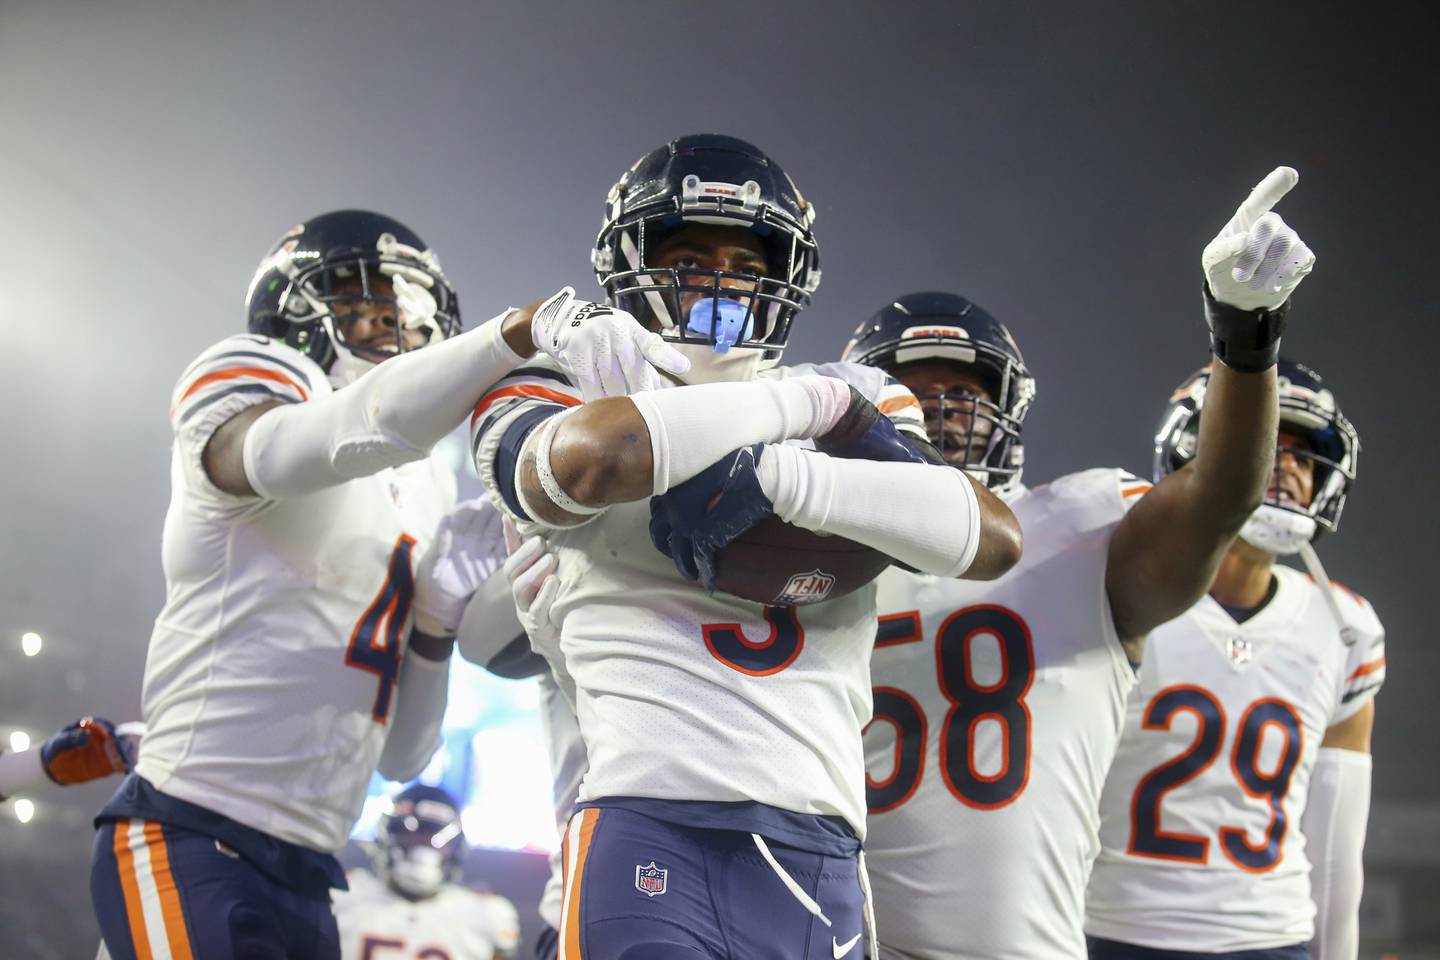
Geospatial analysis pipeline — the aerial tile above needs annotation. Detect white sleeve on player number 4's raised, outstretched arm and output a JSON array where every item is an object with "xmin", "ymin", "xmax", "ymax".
[{"xmin": 245, "ymin": 311, "xmax": 521, "ymax": 499}]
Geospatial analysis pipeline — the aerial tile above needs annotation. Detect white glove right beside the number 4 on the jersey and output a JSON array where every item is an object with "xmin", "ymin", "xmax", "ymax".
[{"xmin": 415, "ymin": 497, "xmax": 505, "ymax": 638}]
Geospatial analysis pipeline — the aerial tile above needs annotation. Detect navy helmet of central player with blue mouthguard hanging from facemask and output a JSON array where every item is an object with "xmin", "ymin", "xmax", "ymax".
[{"xmin": 590, "ymin": 134, "xmax": 819, "ymax": 363}]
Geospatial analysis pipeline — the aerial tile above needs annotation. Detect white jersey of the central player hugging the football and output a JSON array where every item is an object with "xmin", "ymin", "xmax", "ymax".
[{"xmin": 474, "ymin": 356, "xmax": 923, "ymax": 836}]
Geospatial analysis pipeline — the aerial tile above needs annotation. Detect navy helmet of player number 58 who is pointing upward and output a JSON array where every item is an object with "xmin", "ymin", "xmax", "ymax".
[{"xmin": 841, "ymin": 292, "xmax": 1035, "ymax": 494}]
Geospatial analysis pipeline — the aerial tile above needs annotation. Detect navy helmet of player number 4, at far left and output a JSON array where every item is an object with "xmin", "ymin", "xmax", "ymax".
[{"xmin": 245, "ymin": 210, "xmax": 461, "ymax": 383}]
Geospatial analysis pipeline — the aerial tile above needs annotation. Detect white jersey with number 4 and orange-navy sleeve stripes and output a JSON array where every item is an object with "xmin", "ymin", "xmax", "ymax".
[{"xmin": 135, "ymin": 335, "xmax": 455, "ymax": 852}]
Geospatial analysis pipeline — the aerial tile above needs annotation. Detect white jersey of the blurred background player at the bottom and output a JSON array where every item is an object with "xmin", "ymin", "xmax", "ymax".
[{"xmin": 331, "ymin": 869, "xmax": 520, "ymax": 960}]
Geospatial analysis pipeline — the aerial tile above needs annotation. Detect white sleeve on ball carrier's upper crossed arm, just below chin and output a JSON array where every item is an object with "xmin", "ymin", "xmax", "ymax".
[{"xmin": 631, "ymin": 374, "xmax": 850, "ymax": 497}]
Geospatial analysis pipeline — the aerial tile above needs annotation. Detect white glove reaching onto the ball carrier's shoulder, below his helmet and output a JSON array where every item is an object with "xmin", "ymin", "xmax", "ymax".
[{"xmin": 530, "ymin": 286, "xmax": 690, "ymax": 402}]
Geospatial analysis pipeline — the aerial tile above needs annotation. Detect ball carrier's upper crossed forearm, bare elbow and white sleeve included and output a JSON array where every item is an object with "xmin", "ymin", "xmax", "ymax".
[{"xmin": 518, "ymin": 376, "xmax": 851, "ymax": 522}]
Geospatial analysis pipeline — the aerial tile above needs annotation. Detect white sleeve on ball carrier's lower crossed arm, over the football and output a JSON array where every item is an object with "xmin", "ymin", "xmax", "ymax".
[{"xmin": 759, "ymin": 443, "xmax": 981, "ymax": 577}]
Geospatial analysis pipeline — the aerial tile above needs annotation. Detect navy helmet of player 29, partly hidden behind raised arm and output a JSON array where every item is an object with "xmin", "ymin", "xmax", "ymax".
[{"xmin": 1155, "ymin": 357, "xmax": 1359, "ymax": 554}]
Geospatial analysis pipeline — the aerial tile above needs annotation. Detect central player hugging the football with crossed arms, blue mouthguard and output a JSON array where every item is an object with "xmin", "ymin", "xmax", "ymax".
[{"xmin": 472, "ymin": 135, "xmax": 1020, "ymax": 960}]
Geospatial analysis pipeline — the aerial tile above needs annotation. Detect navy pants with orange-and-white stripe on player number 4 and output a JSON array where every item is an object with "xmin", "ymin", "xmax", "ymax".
[{"xmin": 91, "ymin": 819, "xmax": 340, "ymax": 960}]
